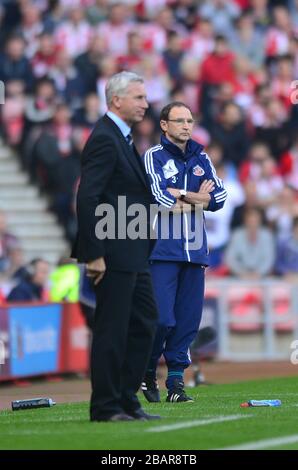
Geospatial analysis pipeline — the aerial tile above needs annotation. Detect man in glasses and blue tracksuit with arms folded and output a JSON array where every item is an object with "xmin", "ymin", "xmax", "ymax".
[{"xmin": 142, "ymin": 102, "xmax": 227, "ymax": 402}]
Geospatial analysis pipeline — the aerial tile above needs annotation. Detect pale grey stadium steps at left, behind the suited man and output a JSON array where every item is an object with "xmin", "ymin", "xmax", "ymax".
[{"xmin": 0, "ymin": 141, "xmax": 70, "ymax": 264}]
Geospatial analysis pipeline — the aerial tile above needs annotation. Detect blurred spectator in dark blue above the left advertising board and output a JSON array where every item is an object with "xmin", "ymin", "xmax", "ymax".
[{"xmin": 7, "ymin": 258, "xmax": 49, "ymax": 302}]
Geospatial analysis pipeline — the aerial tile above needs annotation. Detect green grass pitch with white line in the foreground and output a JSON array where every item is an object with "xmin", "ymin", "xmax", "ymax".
[{"xmin": 0, "ymin": 377, "xmax": 298, "ymax": 450}]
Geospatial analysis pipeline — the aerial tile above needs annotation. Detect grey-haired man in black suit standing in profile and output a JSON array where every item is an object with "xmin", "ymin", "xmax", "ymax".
[{"xmin": 72, "ymin": 72, "xmax": 159, "ymax": 421}]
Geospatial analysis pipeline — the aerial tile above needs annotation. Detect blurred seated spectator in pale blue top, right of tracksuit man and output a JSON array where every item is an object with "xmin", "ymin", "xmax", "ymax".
[{"xmin": 225, "ymin": 208, "xmax": 275, "ymax": 280}]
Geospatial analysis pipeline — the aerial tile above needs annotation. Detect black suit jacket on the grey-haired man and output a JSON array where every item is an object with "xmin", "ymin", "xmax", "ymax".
[{"xmin": 71, "ymin": 115, "xmax": 153, "ymax": 271}]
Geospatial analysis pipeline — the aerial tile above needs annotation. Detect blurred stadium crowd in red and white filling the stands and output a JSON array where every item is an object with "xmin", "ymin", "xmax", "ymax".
[{"xmin": 0, "ymin": 0, "xmax": 298, "ymax": 302}]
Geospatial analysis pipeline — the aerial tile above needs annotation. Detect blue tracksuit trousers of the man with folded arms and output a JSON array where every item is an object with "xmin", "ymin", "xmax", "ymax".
[{"xmin": 148, "ymin": 261, "xmax": 205, "ymax": 371}]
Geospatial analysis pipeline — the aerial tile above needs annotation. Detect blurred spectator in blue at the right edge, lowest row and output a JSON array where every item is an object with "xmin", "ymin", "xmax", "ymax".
[{"xmin": 275, "ymin": 217, "xmax": 298, "ymax": 281}]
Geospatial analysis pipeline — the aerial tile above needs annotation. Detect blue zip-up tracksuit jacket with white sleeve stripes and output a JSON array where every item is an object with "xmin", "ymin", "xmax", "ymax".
[{"xmin": 143, "ymin": 135, "xmax": 227, "ymax": 266}]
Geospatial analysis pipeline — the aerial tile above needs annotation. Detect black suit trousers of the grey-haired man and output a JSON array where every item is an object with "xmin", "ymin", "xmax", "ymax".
[{"xmin": 90, "ymin": 269, "xmax": 157, "ymax": 420}]
